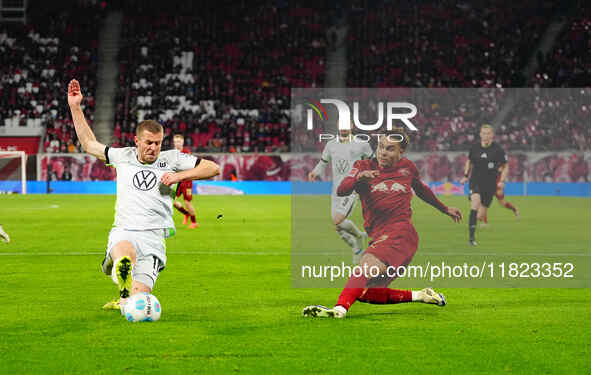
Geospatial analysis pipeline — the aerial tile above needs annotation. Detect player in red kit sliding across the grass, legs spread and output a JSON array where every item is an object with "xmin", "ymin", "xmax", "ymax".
[{"xmin": 303, "ymin": 128, "xmax": 462, "ymax": 318}]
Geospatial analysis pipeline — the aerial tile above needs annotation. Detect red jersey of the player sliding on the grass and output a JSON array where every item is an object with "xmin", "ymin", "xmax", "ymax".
[{"xmin": 337, "ymin": 158, "xmax": 447, "ymax": 238}]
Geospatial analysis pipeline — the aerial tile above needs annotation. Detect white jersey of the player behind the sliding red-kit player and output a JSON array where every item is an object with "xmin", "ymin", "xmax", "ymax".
[{"xmin": 321, "ymin": 139, "xmax": 373, "ymax": 193}]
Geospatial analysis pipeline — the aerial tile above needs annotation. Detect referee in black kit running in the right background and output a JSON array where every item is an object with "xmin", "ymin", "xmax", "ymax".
[{"xmin": 460, "ymin": 124, "xmax": 507, "ymax": 246}]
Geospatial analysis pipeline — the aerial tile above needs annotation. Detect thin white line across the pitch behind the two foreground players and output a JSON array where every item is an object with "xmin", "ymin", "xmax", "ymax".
[{"xmin": 0, "ymin": 251, "xmax": 591, "ymax": 257}]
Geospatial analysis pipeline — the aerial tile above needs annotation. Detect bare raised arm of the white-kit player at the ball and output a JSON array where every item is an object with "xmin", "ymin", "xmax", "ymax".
[{"xmin": 68, "ymin": 79, "xmax": 106, "ymax": 161}]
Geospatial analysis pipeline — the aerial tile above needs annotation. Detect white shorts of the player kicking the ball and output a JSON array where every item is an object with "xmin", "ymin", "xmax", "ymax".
[{"xmin": 107, "ymin": 228, "xmax": 167, "ymax": 289}]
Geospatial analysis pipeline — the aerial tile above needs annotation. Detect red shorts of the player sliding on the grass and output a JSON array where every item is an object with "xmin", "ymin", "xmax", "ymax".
[{"xmin": 365, "ymin": 221, "xmax": 419, "ymax": 280}]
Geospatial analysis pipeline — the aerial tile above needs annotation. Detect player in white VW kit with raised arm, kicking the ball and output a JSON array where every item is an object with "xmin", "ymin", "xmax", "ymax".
[{"xmin": 68, "ymin": 79, "xmax": 219, "ymax": 311}]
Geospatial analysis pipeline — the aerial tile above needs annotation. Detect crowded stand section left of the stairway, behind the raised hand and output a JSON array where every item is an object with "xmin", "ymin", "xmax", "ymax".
[{"xmin": 0, "ymin": 1, "xmax": 103, "ymax": 152}]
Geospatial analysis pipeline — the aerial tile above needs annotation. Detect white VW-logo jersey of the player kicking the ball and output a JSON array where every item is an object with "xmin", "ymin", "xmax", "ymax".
[{"xmin": 106, "ymin": 147, "xmax": 200, "ymax": 231}]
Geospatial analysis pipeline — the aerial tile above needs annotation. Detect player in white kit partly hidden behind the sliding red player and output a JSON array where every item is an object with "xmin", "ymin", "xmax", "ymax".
[{"xmin": 308, "ymin": 130, "xmax": 373, "ymax": 264}]
